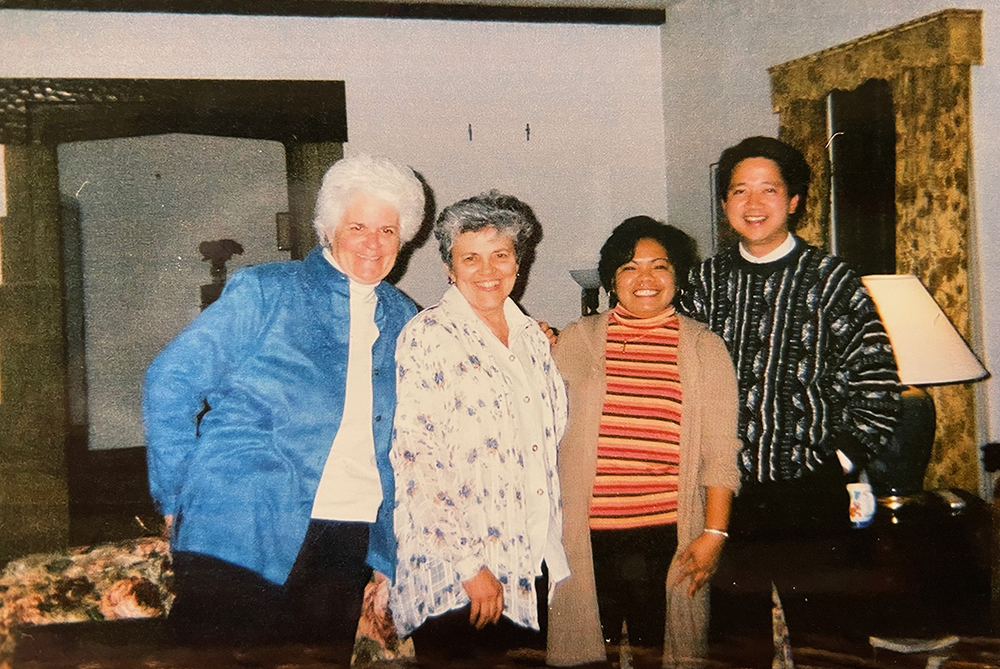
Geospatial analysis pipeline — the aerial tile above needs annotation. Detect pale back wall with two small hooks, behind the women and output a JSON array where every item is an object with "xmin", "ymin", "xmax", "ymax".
[{"xmin": 0, "ymin": 10, "xmax": 666, "ymax": 332}]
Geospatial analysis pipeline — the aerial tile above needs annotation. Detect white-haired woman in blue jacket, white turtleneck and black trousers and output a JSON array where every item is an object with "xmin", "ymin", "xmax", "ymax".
[{"xmin": 143, "ymin": 156, "xmax": 424, "ymax": 649}]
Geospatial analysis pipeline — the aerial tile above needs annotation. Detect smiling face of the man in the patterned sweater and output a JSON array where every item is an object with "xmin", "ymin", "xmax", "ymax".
[{"xmin": 722, "ymin": 158, "xmax": 799, "ymax": 257}]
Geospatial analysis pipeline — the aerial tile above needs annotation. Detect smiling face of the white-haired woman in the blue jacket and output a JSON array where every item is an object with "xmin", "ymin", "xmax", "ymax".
[{"xmin": 328, "ymin": 193, "xmax": 399, "ymax": 285}]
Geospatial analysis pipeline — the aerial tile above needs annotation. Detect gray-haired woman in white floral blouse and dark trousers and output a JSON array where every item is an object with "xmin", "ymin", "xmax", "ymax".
[{"xmin": 390, "ymin": 191, "xmax": 569, "ymax": 666}]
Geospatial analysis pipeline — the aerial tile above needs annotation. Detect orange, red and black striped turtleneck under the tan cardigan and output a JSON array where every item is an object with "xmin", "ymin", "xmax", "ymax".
[{"xmin": 590, "ymin": 305, "xmax": 682, "ymax": 530}]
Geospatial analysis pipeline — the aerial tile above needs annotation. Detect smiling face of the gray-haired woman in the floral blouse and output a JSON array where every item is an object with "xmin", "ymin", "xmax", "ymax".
[{"xmin": 445, "ymin": 227, "xmax": 518, "ymax": 322}]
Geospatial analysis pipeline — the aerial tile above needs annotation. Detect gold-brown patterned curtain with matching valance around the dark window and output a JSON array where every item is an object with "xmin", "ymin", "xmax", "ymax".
[{"xmin": 769, "ymin": 9, "xmax": 982, "ymax": 492}]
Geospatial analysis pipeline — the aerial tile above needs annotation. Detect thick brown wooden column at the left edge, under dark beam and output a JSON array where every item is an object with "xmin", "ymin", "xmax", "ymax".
[{"xmin": 0, "ymin": 145, "xmax": 69, "ymax": 563}]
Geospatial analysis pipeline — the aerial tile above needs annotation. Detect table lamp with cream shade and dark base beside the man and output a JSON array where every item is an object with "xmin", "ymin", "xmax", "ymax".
[{"xmin": 861, "ymin": 274, "xmax": 989, "ymax": 499}]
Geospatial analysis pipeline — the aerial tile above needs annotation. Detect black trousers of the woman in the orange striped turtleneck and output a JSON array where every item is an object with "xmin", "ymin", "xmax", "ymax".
[{"xmin": 590, "ymin": 525, "xmax": 677, "ymax": 648}]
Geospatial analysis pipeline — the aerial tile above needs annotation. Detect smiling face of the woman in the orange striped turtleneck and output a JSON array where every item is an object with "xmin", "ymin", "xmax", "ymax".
[{"xmin": 615, "ymin": 239, "xmax": 676, "ymax": 318}]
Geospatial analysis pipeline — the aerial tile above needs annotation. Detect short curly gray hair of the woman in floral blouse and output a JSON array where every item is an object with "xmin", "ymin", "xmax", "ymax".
[{"xmin": 434, "ymin": 190, "xmax": 541, "ymax": 267}]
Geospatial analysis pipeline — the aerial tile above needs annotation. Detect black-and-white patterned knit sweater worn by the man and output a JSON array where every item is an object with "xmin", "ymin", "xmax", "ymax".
[{"xmin": 680, "ymin": 238, "xmax": 899, "ymax": 483}]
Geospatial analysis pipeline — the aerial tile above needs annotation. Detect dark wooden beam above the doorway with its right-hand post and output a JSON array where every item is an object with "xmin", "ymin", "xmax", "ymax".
[{"xmin": 0, "ymin": 79, "xmax": 347, "ymax": 258}]
